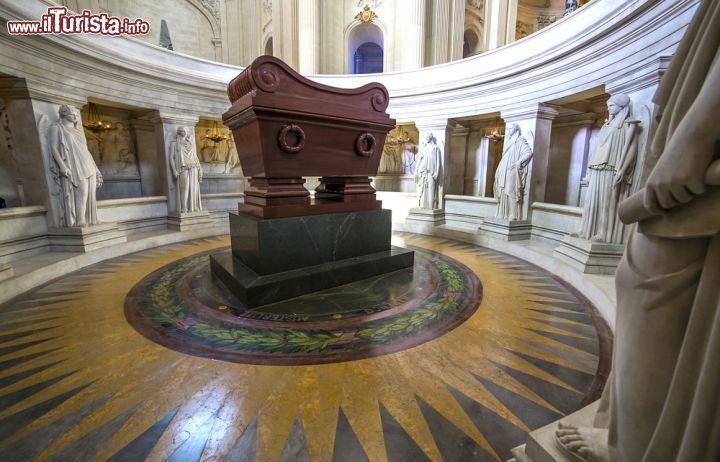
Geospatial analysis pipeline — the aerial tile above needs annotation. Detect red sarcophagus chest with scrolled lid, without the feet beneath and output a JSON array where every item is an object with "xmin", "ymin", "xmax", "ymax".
[{"xmin": 223, "ymin": 56, "xmax": 395, "ymax": 178}]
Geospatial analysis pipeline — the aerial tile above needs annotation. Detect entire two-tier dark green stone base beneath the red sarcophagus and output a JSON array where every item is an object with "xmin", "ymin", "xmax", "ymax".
[{"xmin": 210, "ymin": 210, "xmax": 414, "ymax": 308}]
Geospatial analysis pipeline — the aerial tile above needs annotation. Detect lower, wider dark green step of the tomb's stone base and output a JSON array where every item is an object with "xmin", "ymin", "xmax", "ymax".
[{"xmin": 210, "ymin": 247, "xmax": 414, "ymax": 308}]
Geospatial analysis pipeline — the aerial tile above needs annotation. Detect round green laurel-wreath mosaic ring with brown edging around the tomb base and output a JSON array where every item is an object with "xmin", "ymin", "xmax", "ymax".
[{"xmin": 125, "ymin": 249, "xmax": 482, "ymax": 365}]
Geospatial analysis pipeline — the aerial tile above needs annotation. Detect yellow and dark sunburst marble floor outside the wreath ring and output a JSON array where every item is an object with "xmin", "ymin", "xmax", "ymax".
[{"xmin": 0, "ymin": 234, "xmax": 611, "ymax": 461}]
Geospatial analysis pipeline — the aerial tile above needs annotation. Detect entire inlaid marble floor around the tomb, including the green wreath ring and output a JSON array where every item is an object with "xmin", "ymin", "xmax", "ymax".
[{"xmin": 0, "ymin": 233, "xmax": 612, "ymax": 461}]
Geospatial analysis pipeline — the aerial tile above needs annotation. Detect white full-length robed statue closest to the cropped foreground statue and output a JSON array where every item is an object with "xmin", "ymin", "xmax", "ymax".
[{"xmin": 577, "ymin": 94, "xmax": 640, "ymax": 244}]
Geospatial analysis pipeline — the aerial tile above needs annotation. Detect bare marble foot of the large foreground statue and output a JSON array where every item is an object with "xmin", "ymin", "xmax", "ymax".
[{"xmin": 555, "ymin": 424, "xmax": 608, "ymax": 462}]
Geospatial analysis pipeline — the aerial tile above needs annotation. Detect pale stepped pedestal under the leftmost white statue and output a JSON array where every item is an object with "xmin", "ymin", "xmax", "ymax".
[{"xmin": 48, "ymin": 223, "xmax": 127, "ymax": 252}]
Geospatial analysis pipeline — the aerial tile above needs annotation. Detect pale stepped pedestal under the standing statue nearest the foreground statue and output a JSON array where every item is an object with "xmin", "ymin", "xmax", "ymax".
[{"xmin": 553, "ymin": 236, "xmax": 625, "ymax": 275}]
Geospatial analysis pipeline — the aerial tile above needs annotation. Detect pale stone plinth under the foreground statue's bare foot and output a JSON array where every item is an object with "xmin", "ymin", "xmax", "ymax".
[{"xmin": 508, "ymin": 401, "xmax": 599, "ymax": 462}]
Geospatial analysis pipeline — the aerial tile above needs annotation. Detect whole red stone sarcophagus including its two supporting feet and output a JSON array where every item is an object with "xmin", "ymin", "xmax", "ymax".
[{"xmin": 223, "ymin": 56, "xmax": 395, "ymax": 218}]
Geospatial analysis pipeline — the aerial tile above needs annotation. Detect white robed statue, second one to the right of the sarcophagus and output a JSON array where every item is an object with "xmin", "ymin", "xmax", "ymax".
[{"xmin": 493, "ymin": 124, "xmax": 533, "ymax": 220}]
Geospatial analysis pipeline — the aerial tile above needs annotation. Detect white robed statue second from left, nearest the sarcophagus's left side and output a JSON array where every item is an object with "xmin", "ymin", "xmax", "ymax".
[{"xmin": 169, "ymin": 127, "xmax": 202, "ymax": 212}]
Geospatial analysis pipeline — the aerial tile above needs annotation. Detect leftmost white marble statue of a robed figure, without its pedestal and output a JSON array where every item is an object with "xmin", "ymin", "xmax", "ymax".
[{"xmin": 48, "ymin": 106, "xmax": 103, "ymax": 227}]
